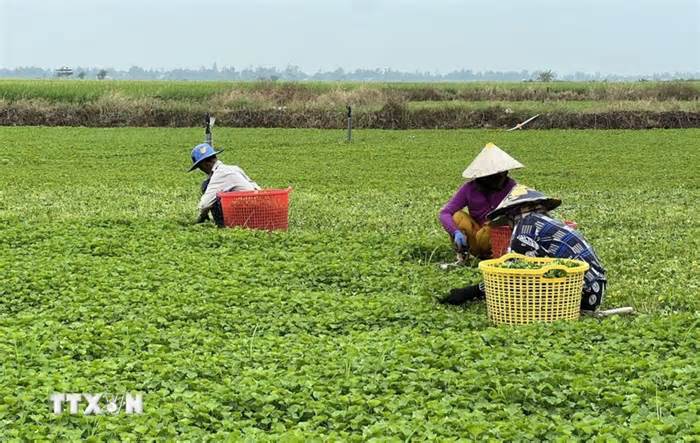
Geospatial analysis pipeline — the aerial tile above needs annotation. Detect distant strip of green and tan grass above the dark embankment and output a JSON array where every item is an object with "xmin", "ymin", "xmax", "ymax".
[{"xmin": 0, "ymin": 79, "xmax": 700, "ymax": 107}]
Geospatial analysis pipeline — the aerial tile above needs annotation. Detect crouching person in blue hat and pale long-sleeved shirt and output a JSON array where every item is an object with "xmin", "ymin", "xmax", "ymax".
[{"xmin": 189, "ymin": 143, "xmax": 260, "ymax": 228}]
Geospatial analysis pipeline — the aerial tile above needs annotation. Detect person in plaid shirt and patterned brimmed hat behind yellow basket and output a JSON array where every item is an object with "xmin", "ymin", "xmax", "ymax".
[{"xmin": 440, "ymin": 185, "xmax": 607, "ymax": 311}]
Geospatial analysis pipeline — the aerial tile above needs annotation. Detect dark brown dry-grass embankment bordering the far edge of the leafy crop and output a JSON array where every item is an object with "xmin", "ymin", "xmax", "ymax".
[{"xmin": 0, "ymin": 102, "xmax": 700, "ymax": 129}]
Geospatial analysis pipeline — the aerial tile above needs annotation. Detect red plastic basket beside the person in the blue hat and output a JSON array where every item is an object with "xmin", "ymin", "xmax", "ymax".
[{"xmin": 216, "ymin": 188, "xmax": 292, "ymax": 231}]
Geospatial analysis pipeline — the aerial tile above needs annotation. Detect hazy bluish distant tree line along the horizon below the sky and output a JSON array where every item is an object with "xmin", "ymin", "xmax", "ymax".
[{"xmin": 0, "ymin": 64, "xmax": 700, "ymax": 82}]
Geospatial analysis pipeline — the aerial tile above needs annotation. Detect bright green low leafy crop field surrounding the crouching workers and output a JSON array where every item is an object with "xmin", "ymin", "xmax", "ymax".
[{"xmin": 0, "ymin": 127, "xmax": 700, "ymax": 441}]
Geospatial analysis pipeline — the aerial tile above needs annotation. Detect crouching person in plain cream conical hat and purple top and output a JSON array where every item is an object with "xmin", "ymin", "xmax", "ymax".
[{"xmin": 439, "ymin": 143, "xmax": 523, "ymax": 258}]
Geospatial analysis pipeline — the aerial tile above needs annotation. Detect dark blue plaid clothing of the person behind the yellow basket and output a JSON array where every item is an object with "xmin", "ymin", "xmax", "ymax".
[{"xmin": 510, "ymin": 212, "xmax": 607, "ymax": 310}]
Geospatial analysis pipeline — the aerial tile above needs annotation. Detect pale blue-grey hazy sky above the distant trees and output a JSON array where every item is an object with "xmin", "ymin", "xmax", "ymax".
[{"xmin": 0, "ymin": 0, "xmax": 700, "ymax": 75}]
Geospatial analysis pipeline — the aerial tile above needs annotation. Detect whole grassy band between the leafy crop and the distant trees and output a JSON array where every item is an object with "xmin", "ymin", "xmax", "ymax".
[{"xmin": 0, "ymin": 81, "xmax": 700, "ymax": 129}]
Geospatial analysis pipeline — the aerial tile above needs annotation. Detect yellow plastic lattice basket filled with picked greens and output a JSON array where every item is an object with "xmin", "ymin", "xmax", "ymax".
[{"xmin": 479, "ymin": 253, "xmax": 589, "ymax": 325}]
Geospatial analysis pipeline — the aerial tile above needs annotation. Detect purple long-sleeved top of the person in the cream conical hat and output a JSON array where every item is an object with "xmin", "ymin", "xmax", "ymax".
[{"xmin": 440, "ymin": 178, "xmax": 515, "ymax": 235}]
